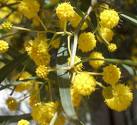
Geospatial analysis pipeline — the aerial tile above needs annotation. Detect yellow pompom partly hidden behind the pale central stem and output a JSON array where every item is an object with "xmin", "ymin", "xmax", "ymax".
[{"xmin": 68, "ymin": 56, "xmax": 83, "ymax": 71}]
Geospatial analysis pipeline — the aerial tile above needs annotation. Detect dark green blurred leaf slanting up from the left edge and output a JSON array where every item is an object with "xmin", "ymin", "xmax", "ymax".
[{"xmin": 0, "ymin": 54, "xmax": 27, "ymax": 82}]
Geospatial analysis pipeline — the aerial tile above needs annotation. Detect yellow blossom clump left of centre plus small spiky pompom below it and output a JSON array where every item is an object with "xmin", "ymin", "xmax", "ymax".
[{"xmin": 25, "ymin": 35, "xmax": 50, "ymax": 79}]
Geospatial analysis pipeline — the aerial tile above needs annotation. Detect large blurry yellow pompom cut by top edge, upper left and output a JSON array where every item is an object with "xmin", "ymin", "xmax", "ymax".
[{"xmin": 18, "ymin": 0, "xmax": 40, "ymax": 19}]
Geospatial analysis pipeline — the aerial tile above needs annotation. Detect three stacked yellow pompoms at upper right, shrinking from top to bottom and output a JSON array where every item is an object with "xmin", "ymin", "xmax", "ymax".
[{"xmin": 99, "ymin": 9, "xmax": 119, "ymax": 52}]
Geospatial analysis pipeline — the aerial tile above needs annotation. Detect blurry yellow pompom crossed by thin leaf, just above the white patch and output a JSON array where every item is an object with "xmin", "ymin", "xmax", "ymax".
[{"xmin": 15, "ymin": 71, "xmax": 33, "ymax": 92}]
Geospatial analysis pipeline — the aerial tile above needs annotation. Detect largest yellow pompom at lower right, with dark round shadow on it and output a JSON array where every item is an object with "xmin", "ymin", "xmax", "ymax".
[{"xmin": 103, "ymin": 84, "xmax": 133, "ymax": 112}]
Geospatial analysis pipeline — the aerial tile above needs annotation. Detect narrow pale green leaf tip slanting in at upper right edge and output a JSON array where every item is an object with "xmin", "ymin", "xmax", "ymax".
[{"xmin": 120, "ymin": 13, "xmax": 137, "ymax": 26}]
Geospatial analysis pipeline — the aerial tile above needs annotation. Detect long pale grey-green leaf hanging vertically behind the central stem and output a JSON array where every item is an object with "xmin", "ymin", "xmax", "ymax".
[{"xmin": 56, "ymin": 39, "xmax": 78, "ymax": 120}]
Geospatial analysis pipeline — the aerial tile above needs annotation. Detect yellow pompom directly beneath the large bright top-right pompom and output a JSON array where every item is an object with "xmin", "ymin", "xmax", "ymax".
[{"xmin": 100, "ymin": 27, "xmax": 114, "ymax": 42}]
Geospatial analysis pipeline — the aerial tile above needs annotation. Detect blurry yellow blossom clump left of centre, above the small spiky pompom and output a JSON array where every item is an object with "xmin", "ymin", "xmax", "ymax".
[{"xmin": 25, "ymin": 37, "xmax": 50, "ymax": 65}]
